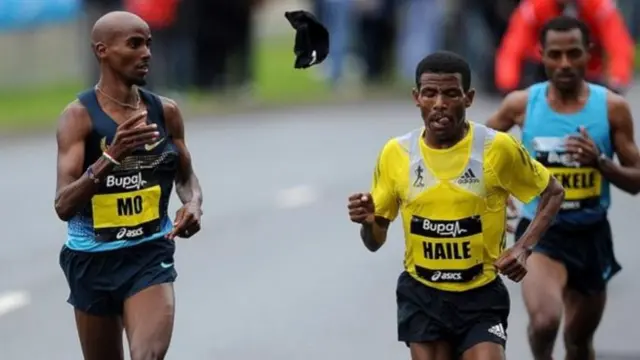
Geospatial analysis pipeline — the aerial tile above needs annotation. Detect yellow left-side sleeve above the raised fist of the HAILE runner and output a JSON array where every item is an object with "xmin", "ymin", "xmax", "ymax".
[{"xmin": 371, "ymin": 139, "xmax": 399, "ymax": 221}]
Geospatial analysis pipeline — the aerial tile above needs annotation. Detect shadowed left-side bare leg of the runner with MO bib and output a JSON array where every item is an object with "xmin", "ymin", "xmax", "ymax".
[{"xmin": 75, "ymin": 310, "xmax": 124, "ymax": 360}]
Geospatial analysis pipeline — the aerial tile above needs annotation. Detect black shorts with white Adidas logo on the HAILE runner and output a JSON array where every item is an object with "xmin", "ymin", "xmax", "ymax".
[{"xmin": 396, "ymin": 272, "xmax": 511, "ymax": 357}]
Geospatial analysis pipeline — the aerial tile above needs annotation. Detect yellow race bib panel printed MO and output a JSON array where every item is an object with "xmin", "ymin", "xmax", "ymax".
[{"xmin": 92, "ymin": 185, "xmax": 162, "ymax": 240}]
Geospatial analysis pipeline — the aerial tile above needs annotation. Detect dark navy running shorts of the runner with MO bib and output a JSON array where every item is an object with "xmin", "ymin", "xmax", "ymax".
[{"xmin": 60, "ymin": 239, "xmax": 178, "ymax": 316}]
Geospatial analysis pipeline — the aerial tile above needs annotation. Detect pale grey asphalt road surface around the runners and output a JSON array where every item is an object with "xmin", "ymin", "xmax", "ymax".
[{"xmin": 0, "ymin": 92, "xmax": 640, "ymax": 360}]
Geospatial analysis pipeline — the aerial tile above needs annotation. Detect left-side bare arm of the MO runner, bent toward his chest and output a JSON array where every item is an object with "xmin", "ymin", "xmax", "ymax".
[{"xmin": 55, "ymin": 102, "xmax": 113, "ymax": 221}]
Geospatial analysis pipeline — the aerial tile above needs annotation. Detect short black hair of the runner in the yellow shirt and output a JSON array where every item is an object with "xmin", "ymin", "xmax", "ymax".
[{"xmin": 416, "ymin": 51, "xmax": 471, "ymax": 91}]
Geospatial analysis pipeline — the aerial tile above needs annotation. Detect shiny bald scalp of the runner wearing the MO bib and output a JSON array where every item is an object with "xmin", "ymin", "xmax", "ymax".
[{"xmin": 91, "ymin": 11, "xmax": 149, "ymax": 46}]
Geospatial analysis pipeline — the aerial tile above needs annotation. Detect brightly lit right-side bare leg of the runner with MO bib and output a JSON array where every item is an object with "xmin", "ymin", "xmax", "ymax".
[{"xmin": 124, "ymin": 283, "xmax": 175, "ymax": 360}]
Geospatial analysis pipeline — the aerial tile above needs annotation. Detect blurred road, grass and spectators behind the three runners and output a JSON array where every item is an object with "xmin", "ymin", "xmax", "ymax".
[{"xmin": 0, "ymin": 0, "xmax": 640, "ymax": 360}]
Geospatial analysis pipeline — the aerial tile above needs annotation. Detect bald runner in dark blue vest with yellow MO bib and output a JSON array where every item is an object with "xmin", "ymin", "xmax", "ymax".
[{"xmin": 55, "ymin": 12, "xmax": 202, "ymax": 360}]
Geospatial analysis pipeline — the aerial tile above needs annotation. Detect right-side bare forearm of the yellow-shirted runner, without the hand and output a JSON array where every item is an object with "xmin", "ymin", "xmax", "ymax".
[{"xmin": 518, "ymin": 176, "xmax": 564, "ymax": 249}]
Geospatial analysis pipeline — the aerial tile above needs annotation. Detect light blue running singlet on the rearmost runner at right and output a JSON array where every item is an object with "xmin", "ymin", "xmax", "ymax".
[{"xmin": 522, "ymin": 82, "xmax": 613, "ymax": 225}]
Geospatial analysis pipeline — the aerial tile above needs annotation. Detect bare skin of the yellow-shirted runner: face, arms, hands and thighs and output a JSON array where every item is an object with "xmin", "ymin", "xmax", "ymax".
[{"xmin": 347, "ymin": 73, "xmax": 563, "ymax": 360}]
